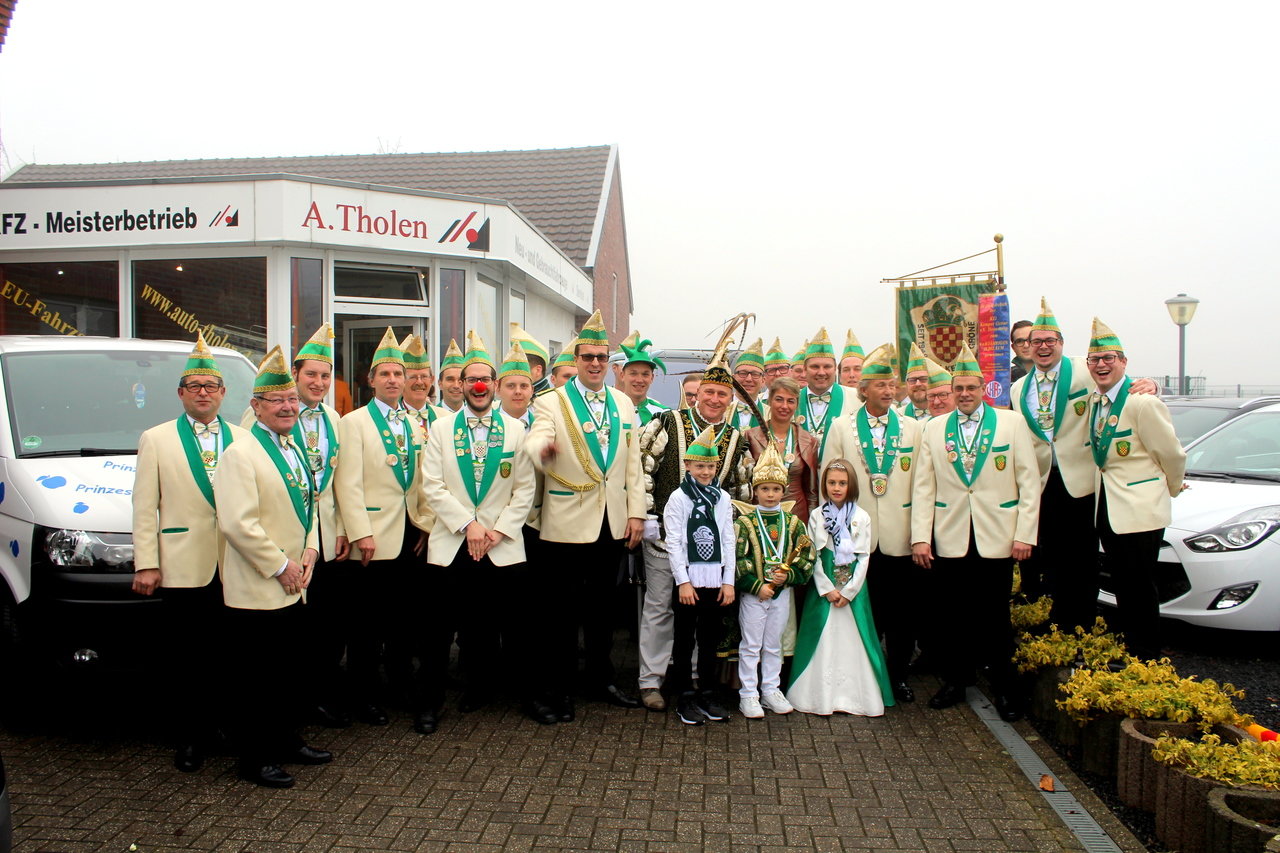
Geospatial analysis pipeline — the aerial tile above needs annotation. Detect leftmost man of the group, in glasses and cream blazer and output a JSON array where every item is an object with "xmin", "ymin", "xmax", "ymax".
[{"xmin": 133, "ymin": 334, "xmax": 248, "ymax": 772}]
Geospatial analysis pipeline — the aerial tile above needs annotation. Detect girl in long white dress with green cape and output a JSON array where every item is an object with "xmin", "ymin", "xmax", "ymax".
[{"xmin": 787, "ymin": 459, "xmax": 893, "ymax": 717}]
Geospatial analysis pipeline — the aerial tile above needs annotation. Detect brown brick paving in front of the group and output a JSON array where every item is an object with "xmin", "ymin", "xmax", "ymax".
[{"xmin": 0, "ymin": 679, "xmax": 1080, "ymax": 853}]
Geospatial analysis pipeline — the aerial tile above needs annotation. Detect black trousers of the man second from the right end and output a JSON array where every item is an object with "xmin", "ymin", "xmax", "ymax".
[{"xmin": 1019, "ymin": 465, "xmax": 1098, "ymax": 631}]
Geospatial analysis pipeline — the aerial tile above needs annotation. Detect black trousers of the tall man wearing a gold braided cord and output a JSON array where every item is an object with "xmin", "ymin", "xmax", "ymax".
[{"xmin": 538, "ymin": 514, "xmax": 625, "ymax": 695}]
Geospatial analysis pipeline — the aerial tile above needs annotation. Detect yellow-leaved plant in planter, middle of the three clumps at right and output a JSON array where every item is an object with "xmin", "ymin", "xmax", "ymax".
[{"xmin": 1057, "ymin": 657, "xmax": 1252, "ymax": 733}]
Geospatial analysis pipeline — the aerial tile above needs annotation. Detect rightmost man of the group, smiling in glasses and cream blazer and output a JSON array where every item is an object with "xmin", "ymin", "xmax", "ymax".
[{"xmin": 1085, "ymin": 318, "xmax": 1187, "ymax": 661}]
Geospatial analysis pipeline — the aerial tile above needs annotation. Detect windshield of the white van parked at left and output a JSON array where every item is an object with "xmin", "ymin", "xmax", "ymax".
[{"xmin": 0, "ymin": 350, "xmax": 253, "ymax": 457}]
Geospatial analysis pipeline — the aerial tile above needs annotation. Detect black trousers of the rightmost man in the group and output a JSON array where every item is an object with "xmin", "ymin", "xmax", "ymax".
[{"xmin": 1097, "ymin": 485, "xmax": 1165, "ymax": 660}]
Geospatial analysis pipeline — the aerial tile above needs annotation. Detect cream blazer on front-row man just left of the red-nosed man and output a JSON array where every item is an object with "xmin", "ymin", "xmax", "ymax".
[{"xmin": 333, "ymin": 406, "xmax": 431, "ymax": 560}]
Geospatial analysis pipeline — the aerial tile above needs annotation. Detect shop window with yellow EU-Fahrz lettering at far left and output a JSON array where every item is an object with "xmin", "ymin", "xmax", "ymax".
[{"xmin": 0, "ymin": 261, "xmax": 120, "ymax": 337}]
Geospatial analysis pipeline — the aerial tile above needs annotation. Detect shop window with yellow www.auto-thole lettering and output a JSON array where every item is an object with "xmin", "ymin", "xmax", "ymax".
[{"xmin": 133, "ymin": 257, "xmax": 267, "ymax": 364}]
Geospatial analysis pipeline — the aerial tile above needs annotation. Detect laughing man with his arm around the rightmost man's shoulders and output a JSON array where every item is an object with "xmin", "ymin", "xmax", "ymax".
[{"xmin": 1010, "ymin": 298, "xmax": 1156, "ymax": 631}]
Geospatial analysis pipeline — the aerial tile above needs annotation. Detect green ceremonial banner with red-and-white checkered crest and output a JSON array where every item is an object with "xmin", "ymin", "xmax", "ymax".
[{"xmin": 897, "ymin": 282, "xmax": 993, "ymax": 378}]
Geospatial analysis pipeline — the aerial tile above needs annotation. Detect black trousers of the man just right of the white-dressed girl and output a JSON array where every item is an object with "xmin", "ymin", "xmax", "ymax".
[{"xmin": 867, "ymin": 548, "xmax": 933, "ymax": 683}]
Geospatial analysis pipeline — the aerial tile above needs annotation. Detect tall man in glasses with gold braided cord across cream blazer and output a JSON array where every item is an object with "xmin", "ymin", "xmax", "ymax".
[{"xmin": 525, "ymin": 311, "xmax": 645, "ymax": 722}]
